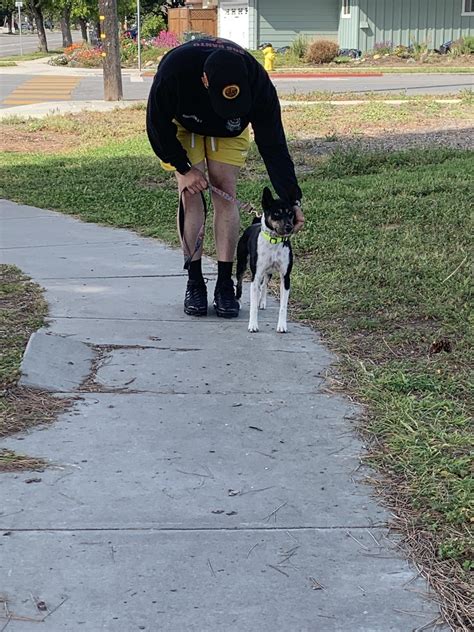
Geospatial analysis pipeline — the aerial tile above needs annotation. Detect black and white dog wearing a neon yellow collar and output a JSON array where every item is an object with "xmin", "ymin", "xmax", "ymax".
[{"xmin": 237, "ymin": 187, "xmax": 295, "ymax": 333}]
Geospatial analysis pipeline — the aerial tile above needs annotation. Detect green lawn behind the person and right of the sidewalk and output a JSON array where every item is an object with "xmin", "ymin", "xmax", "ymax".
[{"xmin": 1, "ymin": 110, "xmax": 474, "ymax": 630}]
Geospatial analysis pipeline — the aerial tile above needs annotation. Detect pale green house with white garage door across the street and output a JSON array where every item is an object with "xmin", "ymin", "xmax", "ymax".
[{"xmin": 218, "ymin": 0, "xmax": 474, "ymax": 52}]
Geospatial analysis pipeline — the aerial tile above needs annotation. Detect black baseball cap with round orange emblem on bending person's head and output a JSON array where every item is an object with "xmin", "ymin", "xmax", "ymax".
[{"xmin": 203, "ymin": 50, "xmax": 252, "ymax": 119}]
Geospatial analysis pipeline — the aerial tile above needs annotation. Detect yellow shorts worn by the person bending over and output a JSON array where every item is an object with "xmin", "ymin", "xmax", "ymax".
[{"xmin": 160, "ymin": 122, "xmax": 250, "ymax": 171}]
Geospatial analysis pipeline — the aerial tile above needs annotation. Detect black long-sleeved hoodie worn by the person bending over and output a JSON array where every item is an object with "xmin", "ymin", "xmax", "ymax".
[{"xmin": 147, "ymin": 38, "xmax": 301, "ymax": 202}]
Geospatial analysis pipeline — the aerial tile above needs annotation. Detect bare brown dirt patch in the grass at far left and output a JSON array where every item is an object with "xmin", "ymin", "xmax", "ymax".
[{"xmin": 2, "ymin": 125, "xmax": 77, "ymax": 154}]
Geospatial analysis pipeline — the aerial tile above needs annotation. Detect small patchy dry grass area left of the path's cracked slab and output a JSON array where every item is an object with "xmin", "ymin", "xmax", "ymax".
[{"xmin": 0, "ymin": 265, "xmax": 66, "ymax": 472}]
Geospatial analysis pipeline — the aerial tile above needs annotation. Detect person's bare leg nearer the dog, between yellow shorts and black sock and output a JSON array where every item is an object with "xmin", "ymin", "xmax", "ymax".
[{"xmin": 207, "ymin": 160, "xmax": 240, "ymax": 261}]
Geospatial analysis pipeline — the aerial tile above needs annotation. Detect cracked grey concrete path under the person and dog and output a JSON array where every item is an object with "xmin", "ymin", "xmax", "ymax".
[{"xmin": 0, "ymin": 201, "xmax": 440, "ymax": 632}]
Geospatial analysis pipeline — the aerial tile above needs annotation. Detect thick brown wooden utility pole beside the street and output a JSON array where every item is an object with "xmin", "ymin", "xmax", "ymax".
[{"xmin": 99, "ymin": 0, "xmax": 123, "ymax": 101}]
